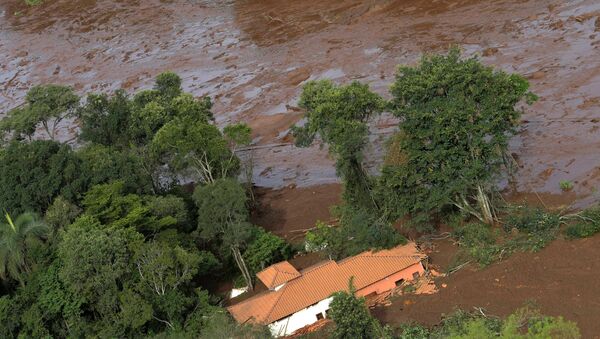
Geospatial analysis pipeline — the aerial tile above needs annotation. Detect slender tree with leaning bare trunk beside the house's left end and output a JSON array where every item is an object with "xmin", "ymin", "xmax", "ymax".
[{"xmin": 194, "ymin": 178, "xmax": 254, "ymax": 290}]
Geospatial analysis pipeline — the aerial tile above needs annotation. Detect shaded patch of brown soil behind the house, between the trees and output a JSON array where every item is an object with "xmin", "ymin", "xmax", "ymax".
[{"xmin": 251, "ymin": 184, "xmax": 342, "ymax": 243}]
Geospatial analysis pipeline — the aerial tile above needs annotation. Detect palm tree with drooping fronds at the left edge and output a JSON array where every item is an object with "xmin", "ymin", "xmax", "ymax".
[{"xmin": 0, "ymin": 213, "xmax": 48, "ymax": 286}]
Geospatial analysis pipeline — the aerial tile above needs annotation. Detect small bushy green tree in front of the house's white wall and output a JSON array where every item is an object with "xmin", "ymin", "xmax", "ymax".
[{"xmin": 328, "ymin": 278, "xmax": 386, "ymax": 339}]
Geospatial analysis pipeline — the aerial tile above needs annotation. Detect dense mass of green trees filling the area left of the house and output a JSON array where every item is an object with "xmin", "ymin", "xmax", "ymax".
[{"xmin": 0, "ymin": 73, "xmax": 280, "ymax": 338}]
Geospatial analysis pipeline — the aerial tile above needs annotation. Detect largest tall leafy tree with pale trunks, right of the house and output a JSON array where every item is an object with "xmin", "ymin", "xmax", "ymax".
[{"xmin": 378, "ymin": 49, "xmax": 536, "ymax": 228}]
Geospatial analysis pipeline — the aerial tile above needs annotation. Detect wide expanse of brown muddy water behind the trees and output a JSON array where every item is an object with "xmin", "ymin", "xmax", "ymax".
[{"xmin": 0, "ymin": 0, "xmax": 600, "ymax": 204}]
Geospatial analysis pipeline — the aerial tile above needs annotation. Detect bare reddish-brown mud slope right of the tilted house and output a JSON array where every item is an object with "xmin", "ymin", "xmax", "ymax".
[{"xmin": 373, "ymin": 235, "xmax": 600, "ymax": 338}]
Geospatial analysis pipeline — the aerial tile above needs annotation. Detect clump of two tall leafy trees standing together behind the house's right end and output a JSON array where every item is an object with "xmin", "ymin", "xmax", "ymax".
[{"xmin": 292, "ymin": 48, "xmax": 537, "ymax": 244}]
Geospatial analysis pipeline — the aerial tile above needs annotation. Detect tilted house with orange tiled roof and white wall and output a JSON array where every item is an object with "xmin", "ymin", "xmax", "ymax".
[{"xmin": 227, "ymin": 243, "xmax": 425, "ymax": 336}]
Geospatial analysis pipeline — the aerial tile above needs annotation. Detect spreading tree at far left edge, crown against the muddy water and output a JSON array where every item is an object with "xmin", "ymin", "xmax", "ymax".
[{"xmin": 0, "ymin": 85, "xmax": 79, "ymax": 140}]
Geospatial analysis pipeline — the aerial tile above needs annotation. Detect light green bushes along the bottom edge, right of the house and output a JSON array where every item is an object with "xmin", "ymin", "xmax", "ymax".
[{"xmin": 398, "ymin": 306, "xmax": 581, "ymax": 339}]
